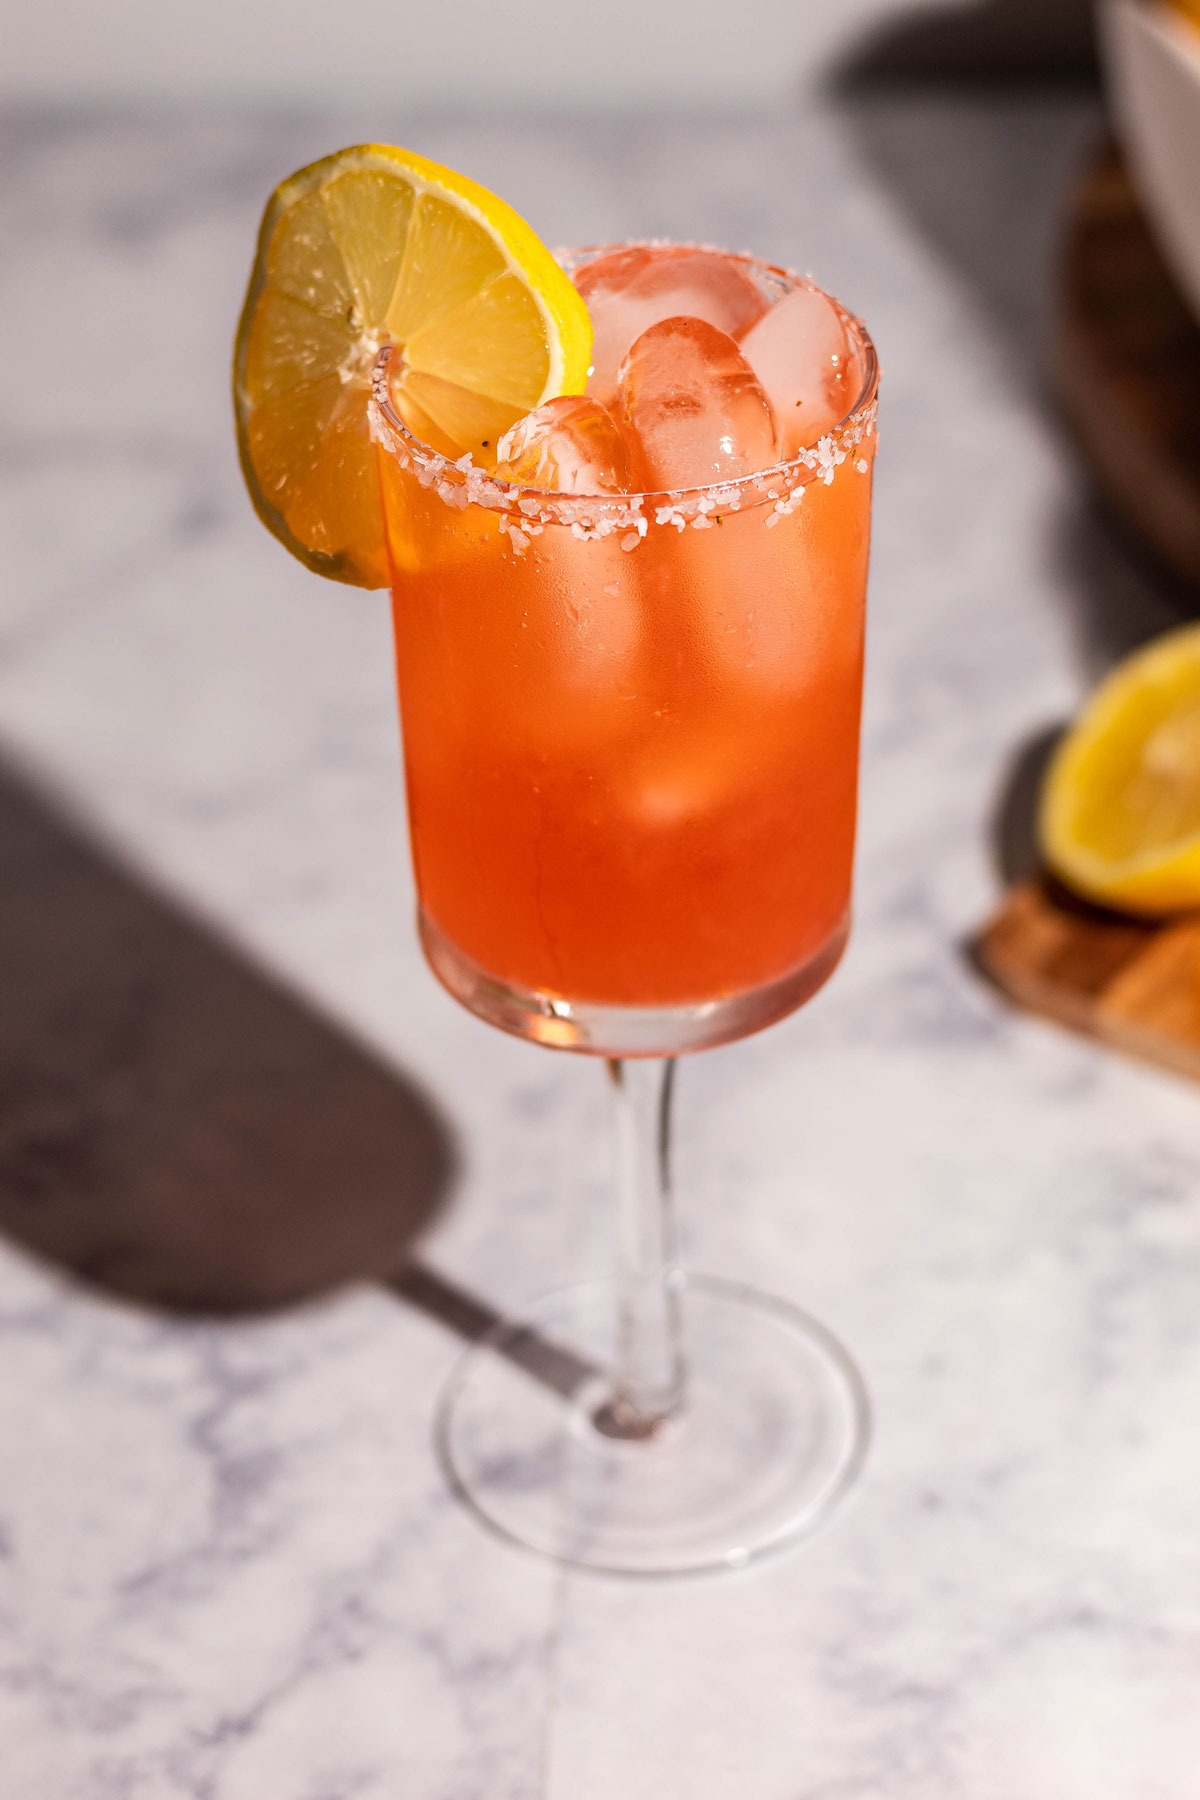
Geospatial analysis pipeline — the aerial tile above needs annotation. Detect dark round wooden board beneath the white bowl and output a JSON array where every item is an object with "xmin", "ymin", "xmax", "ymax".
[{"xmin": 1056, "ymin": 146, "xmax": 1200, "ymax": 590}]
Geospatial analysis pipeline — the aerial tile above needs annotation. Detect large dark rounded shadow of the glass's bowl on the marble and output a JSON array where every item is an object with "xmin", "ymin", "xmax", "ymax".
[{"xmin": 0, "ymin": 752, "xmax": 455, "ymax": 1312}]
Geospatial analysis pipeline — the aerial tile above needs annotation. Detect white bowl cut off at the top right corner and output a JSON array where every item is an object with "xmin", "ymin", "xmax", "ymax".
[{"xmin": 1099, "ymin": 0, "xmax": 1200, "ymax": 319}]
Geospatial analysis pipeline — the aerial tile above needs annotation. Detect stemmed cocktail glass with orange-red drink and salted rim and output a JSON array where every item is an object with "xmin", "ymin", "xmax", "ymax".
[{"xmin": 372, "ymin": 248, "xmax": 876, "ymax": 1575}]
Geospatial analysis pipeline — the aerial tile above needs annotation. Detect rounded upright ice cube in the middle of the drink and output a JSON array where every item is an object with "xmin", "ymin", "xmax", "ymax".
[{"xmin": 621, "ymin": 319, "xmax": 779, "ymax": 493}]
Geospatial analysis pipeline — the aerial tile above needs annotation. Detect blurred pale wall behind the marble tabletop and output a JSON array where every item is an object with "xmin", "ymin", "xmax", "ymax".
[{"xmin": 0, "ymin": 0, "xmax": 1087, "ymax": 110}]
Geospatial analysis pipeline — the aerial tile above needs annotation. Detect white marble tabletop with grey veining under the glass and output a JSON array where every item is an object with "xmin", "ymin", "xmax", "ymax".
[{"xmin": 0, "ymin": 95, "xmax": 1200, "ymax": 1800}]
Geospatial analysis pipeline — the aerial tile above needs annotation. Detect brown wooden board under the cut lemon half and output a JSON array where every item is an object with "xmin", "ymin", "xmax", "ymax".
[{"xmin": 975, "ymin": 878, "xmax": 1200, "ymax": 1080}]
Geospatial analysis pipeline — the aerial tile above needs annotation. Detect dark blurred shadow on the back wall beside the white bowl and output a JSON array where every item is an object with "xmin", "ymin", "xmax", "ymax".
[{"xmin": 844, "ymin": 0, "xmax": 1096, "ymax": 83}]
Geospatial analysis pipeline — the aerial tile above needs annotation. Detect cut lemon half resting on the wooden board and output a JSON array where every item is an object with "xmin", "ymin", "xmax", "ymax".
[{"xmin": 1040, "ymin": 625, "xmax": 1200, "ymax": 914}]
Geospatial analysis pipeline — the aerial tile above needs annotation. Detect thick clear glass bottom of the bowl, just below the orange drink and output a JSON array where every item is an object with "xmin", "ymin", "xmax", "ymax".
[{"xmin": 417, "ymin": 913, "xmax": 849, "ymax": 1057}]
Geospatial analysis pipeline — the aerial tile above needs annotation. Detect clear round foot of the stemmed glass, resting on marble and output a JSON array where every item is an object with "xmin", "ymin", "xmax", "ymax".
[{"xmin": 437, "ymin": 1273, "xmax": 869, "ymax": 1575}]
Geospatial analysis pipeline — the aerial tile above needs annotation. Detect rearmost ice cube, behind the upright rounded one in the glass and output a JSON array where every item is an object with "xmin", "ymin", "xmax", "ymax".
[{"xmin": 574, "ymin": 245, "xmax": 766, "ymax": 407}]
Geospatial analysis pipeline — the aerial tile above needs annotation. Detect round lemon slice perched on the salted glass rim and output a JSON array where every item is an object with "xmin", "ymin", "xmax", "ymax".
[{"xmin": 234, "ymin": 144, "xmax": 592, "ymax": 587}]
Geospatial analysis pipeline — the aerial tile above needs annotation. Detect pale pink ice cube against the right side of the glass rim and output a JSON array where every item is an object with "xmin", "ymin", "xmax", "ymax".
[{"xmin": 739, "ymin": 286, "xmax": 858, "ymax": 459}]
